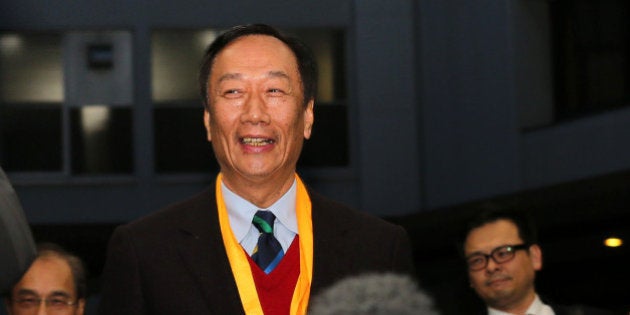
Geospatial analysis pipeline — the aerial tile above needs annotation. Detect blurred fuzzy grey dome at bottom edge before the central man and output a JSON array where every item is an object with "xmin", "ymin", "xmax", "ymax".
[{"xmin": 308, "ymin": 273, "xmax": 439, "ymax": 315}]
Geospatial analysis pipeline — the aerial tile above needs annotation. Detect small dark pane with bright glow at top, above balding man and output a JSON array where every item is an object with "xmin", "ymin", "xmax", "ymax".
[{"xmin": 70, "ymin": 106, "xmax": 133, "ymax": 174}]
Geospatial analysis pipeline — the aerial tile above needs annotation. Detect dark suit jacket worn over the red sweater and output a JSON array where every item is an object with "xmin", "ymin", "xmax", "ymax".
[{"xmin": 99, "ymin": 188, "xmax": 413, "ymax": 315}]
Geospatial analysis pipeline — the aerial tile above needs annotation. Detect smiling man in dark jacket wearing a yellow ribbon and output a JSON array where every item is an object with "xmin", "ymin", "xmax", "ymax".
[{"xmin": 100, "ymin": 24, "xmax": 413, "ymax": 315}]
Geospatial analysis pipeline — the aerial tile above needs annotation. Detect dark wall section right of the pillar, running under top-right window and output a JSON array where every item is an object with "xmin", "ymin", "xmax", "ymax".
[{"xmin": 416, "ymin": 0, "xmax": 630, "ymax": 209}]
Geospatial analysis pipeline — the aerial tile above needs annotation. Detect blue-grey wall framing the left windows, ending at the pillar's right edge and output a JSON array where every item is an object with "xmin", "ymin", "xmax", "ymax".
[{"xmin": 0, "ymin": 0, "xmax": 421, "ymax": 224}]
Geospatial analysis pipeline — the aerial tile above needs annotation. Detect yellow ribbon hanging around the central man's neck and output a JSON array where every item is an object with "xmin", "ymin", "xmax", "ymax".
[{"xmin": 216, "ymin": 173, "xmax": 313, "ymax": 314}]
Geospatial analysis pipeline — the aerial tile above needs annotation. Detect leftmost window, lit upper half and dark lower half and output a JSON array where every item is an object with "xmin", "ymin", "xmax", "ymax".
[{"xmin": 0, "ymin": 32, "xmax": 63, "ymax": 172}]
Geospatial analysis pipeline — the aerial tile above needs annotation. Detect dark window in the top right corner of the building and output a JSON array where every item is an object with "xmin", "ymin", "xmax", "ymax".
[{"xmin": 551, "ymin": 0, "xmax": 630, "ymax": 120}]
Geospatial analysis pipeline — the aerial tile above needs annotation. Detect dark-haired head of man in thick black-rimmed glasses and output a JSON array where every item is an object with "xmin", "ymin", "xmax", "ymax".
[{"xmin": 463, "ymin": 211, "xmax": 542, "ymax": 311}]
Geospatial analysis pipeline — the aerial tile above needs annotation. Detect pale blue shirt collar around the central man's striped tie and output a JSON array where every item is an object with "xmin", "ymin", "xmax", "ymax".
[{"xmin": 221, "ymin": 180, "xmax": 298, "ymax": 243}]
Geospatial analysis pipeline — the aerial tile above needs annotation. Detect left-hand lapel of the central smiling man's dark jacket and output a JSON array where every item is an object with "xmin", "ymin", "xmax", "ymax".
[{"xmin": 176, "ymin": 187, "xmax": 248, "ymax": 314}]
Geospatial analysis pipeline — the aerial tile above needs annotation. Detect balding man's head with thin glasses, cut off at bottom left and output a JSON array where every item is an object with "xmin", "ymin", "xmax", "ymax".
[{"xmin": 6, "ymin": 244, "xmax": 87, "ymax": 315}]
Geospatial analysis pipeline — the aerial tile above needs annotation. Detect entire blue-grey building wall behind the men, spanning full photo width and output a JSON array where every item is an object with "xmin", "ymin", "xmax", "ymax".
[{"xmin": 0, "ymin": 0, "xmax": 630, "ymax": 223}]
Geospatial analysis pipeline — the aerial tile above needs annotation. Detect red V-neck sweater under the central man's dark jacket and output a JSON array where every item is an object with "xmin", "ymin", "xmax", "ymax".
[{"xmin": 247, "ymin": 235, "xmax": 300, "ymax": 315}]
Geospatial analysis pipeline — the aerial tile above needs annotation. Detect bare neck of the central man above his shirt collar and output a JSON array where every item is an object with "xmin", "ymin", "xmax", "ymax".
[{"xmin": 223, "ymin": 172, "xmax": 295, "ymax": 209}]
